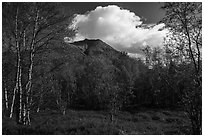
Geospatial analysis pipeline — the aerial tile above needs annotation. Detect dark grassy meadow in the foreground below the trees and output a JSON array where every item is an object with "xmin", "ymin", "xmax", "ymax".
[{"xmin": 2, "ymin": 110, "xmax": 190, "ymax": 135}]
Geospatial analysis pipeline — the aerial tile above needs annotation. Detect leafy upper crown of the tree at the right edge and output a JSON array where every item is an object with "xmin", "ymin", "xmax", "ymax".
[{"xmin": 162, "ymin": 2, "xmax": 202, "ymax": 74}]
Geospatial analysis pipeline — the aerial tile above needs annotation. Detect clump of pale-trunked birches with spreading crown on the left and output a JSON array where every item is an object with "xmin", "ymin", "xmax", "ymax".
[{"xmin": 3, "ymin": 3, "xmax": 74, "ymax": 125}]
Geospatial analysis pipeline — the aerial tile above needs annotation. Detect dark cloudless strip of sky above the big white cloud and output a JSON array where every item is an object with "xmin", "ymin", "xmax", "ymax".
[{"xmin": 62, "ymin": 2, "xmax": 165, "ymax": 23}]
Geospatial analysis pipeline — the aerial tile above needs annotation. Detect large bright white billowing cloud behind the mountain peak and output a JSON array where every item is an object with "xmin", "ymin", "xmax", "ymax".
[{"xmin": 70, "ymin": 5, "xmax": 167, "ymax": 55}]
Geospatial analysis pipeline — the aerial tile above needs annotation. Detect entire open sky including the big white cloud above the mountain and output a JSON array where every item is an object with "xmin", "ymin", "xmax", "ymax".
[{"xmin": 62, "ymin": 2, "xmax": 168, "ymax": 57}]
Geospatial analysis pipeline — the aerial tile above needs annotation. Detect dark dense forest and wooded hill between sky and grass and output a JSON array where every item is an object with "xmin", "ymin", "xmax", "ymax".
[{"xmin": 2, "ymin": 3, "xmax": 202, "ymax": 134}]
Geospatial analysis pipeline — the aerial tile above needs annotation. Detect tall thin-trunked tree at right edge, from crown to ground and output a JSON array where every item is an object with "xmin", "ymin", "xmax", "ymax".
[{"xmin": 162, "ymin": 2, "xmax": 202, "ymax": 134}]
